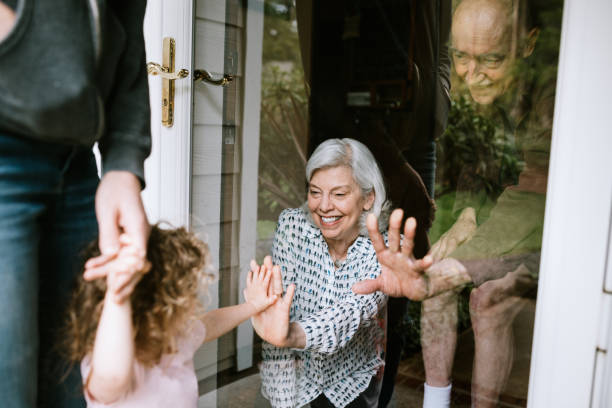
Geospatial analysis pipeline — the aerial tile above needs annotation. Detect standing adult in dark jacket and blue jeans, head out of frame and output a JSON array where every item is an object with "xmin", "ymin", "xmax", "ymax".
[{"xmin": 0, "ymin": 0, "xmax": 150, "ymax": 408}]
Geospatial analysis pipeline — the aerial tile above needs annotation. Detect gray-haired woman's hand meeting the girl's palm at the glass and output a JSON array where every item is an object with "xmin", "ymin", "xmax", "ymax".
[{"xmin": 251, "ymin": 256, "xmax": 295, "ymax": 347}]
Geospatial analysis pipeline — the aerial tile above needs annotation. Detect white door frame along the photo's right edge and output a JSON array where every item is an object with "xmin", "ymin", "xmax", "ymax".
[{"xmin": 528, "ymin": 0, "xmax": 612, "ymax": 408}]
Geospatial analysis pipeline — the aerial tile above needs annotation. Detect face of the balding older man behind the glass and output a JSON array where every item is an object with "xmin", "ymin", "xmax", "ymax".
[{"xmin": 451, "ymin": 8, "xmax": 514, "ymax": 105}]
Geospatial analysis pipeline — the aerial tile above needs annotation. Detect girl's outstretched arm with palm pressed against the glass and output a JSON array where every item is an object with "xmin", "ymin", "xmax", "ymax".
[{"xmin": 202, "ymin": 270, "xmax": 277, "ymax": 342}]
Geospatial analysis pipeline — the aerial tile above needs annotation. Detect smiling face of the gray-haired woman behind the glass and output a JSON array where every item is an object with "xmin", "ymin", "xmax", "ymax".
[{"xmin": 308, "ymin": 166, "xmax": 374, "ymax": 244}]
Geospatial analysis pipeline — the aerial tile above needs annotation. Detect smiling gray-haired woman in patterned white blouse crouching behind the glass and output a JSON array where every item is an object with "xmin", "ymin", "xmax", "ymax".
[{"xmin": 252, "ymin": 139, "xmax": 389, "ymax": 407}]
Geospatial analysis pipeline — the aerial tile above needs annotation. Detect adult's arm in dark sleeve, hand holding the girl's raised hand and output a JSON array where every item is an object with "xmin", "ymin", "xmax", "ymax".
[{"xmin": 85, "ymin": 0, "xmax": 151, "ymax": 299}]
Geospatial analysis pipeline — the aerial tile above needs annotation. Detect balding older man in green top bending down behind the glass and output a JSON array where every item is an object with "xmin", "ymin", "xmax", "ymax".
[{"xmin": 354, "ymin": 0, "xmax": 554, "ymax": 407}]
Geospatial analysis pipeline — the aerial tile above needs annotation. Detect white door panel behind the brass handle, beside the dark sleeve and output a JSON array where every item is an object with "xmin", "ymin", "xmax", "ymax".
[{"xmin": 143, "ymin": 0, "xmax": 193, "ymax": 228}]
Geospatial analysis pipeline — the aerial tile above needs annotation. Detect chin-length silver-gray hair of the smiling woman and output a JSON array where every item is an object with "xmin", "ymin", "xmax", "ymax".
[{"xmin": 306, "ymin": 138, "xmax": 391, "ymax": 236}]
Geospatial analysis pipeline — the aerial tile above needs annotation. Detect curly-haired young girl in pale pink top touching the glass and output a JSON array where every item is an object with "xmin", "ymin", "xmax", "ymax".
[{"xmin": 65, "ymin": 226, "xmax": 276, "ymax": 408}]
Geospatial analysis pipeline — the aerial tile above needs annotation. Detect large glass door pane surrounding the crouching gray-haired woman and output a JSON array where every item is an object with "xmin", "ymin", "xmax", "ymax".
[{"xmin": 207, "ymin": 0, "xmax": 563, "ymax": 407}]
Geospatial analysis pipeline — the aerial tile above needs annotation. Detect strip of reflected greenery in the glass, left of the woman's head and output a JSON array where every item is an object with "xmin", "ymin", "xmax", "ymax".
[{"xmin": 258, "ymin": 0, "xmax": 308, "ymax": 221}]
